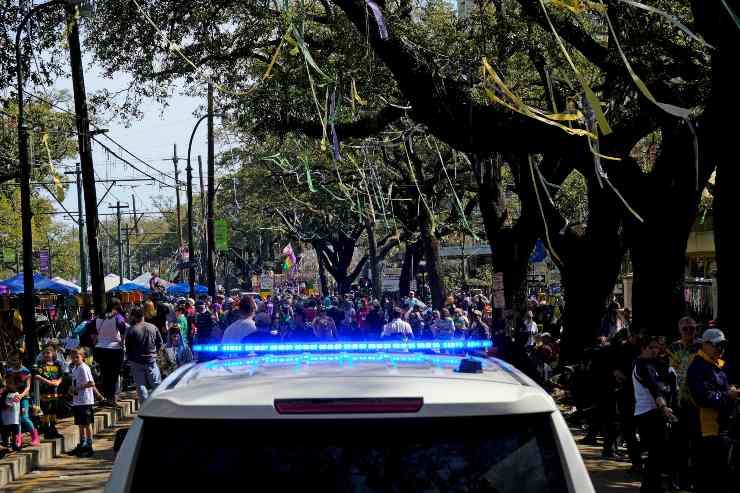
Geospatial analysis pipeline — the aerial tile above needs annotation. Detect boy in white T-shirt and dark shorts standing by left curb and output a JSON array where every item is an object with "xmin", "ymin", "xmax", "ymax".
[{"xmin": 68, "ymin": 348, "xmax": 95, "ymax": 457}]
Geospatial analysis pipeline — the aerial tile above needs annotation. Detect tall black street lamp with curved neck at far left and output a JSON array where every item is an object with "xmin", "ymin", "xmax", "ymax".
[{"xmin": 15, "ymin": 0, "xmax": 94, "ymax": 358}]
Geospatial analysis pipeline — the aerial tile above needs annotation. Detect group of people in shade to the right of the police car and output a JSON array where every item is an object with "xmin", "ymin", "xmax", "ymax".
[{"xmin": 560, "ymin": 317, "xmax": 738, "ymax": 492}]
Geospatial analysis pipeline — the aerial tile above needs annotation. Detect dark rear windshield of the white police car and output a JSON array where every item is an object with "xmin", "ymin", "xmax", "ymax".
[{"xmin": 131, "ymin": 414, "xmax": 567, "ymax": 493}]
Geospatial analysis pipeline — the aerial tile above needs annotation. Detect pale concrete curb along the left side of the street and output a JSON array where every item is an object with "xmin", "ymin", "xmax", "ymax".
[{"xmin": 0, "ymin": 396, "xmax": 138, "ymax": 488}]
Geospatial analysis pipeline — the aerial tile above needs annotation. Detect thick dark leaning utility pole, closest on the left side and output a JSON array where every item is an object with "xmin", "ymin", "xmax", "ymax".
[{"xmin": 64, "ymin": 4, "xmax": 105, "ymax": 313}]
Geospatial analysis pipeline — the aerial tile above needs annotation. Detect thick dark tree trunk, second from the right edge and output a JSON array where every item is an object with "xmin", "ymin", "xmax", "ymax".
[{"xmin": 622, "ymin": 123, "xmax": 713, "ymax": 337}]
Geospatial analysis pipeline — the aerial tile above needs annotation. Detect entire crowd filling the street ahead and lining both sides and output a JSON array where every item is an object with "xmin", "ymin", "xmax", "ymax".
[{"xmin": 0, "ymin": 284, "xmax": 738, "ymax": 492}]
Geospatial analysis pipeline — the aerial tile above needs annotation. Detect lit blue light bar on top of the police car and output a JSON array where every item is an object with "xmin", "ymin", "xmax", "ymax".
[{"xmin": 193, "ymin": 339, "xmax": 493, "ymax": 353}]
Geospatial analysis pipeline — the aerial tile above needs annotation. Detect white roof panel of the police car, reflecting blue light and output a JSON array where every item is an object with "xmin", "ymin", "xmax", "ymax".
[{"xmin": 139, "ymin": 353, "xmax": 557, "ymax": 419}]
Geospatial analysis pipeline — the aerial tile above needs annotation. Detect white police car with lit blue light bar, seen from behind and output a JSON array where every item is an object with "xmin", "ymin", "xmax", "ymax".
[{"xmin": 106, "ymin": 342, "xmax": 593, "ymax": 493}]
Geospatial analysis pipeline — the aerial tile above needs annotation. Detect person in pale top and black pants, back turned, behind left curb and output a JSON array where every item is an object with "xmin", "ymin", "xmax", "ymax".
[{"xmin": 94, "ymin": 298, "xmax": 127, "ymax": 406}]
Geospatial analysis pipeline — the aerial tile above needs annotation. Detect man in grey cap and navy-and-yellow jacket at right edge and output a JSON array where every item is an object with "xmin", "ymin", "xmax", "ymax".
[{"xmin": 686, "ymin": 328, "xmax": 738, "ymax": 493}]
